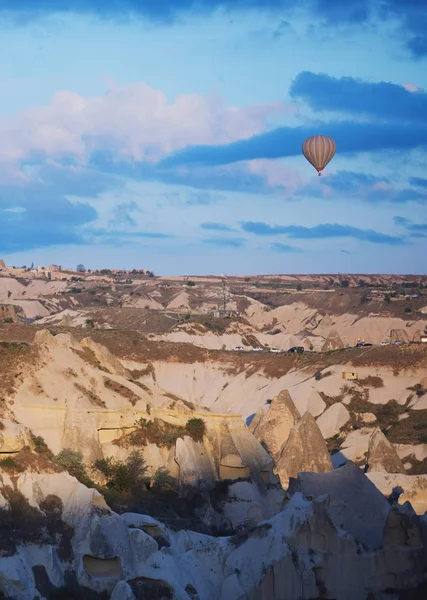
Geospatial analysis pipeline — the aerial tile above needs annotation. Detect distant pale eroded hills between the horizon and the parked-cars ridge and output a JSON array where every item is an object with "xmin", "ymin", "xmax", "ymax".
[{"xmin": 0, "ymin": 264, "xmax": 427, "ymax": 351}]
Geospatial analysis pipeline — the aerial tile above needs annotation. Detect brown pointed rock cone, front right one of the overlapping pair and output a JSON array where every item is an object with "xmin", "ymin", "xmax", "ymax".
[{"xmin": 274, "ymin": 412, "xmax": 332, "ymax": 488}]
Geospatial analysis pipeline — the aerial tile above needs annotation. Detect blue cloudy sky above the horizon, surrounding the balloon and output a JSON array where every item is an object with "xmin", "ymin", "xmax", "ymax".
[{"xmin": 0, "ymin": 0, "xmax": 427, "ymax": 274}]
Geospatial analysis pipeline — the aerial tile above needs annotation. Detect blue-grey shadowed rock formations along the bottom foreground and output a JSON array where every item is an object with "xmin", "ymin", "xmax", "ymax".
[{"xmin": 0, "ymin": 472, "xmax": 427, "ymax": 600}]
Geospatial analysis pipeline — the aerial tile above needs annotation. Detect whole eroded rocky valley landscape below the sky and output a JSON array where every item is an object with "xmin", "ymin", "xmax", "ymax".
[{"xmin": 0, "ymin": 276, "xmax": 427, "ymax": 600}]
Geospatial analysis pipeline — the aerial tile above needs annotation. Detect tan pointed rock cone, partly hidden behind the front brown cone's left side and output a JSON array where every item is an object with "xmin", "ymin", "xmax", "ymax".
[{"xmin": 249, "ymin": 390, "xmax": 301, "ymax": 461}]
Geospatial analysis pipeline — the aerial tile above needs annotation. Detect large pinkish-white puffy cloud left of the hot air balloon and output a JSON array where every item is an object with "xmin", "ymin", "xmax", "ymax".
[{"xmin": 0, "ymin": 82, "xmax": 288, "ymax": 165}]
